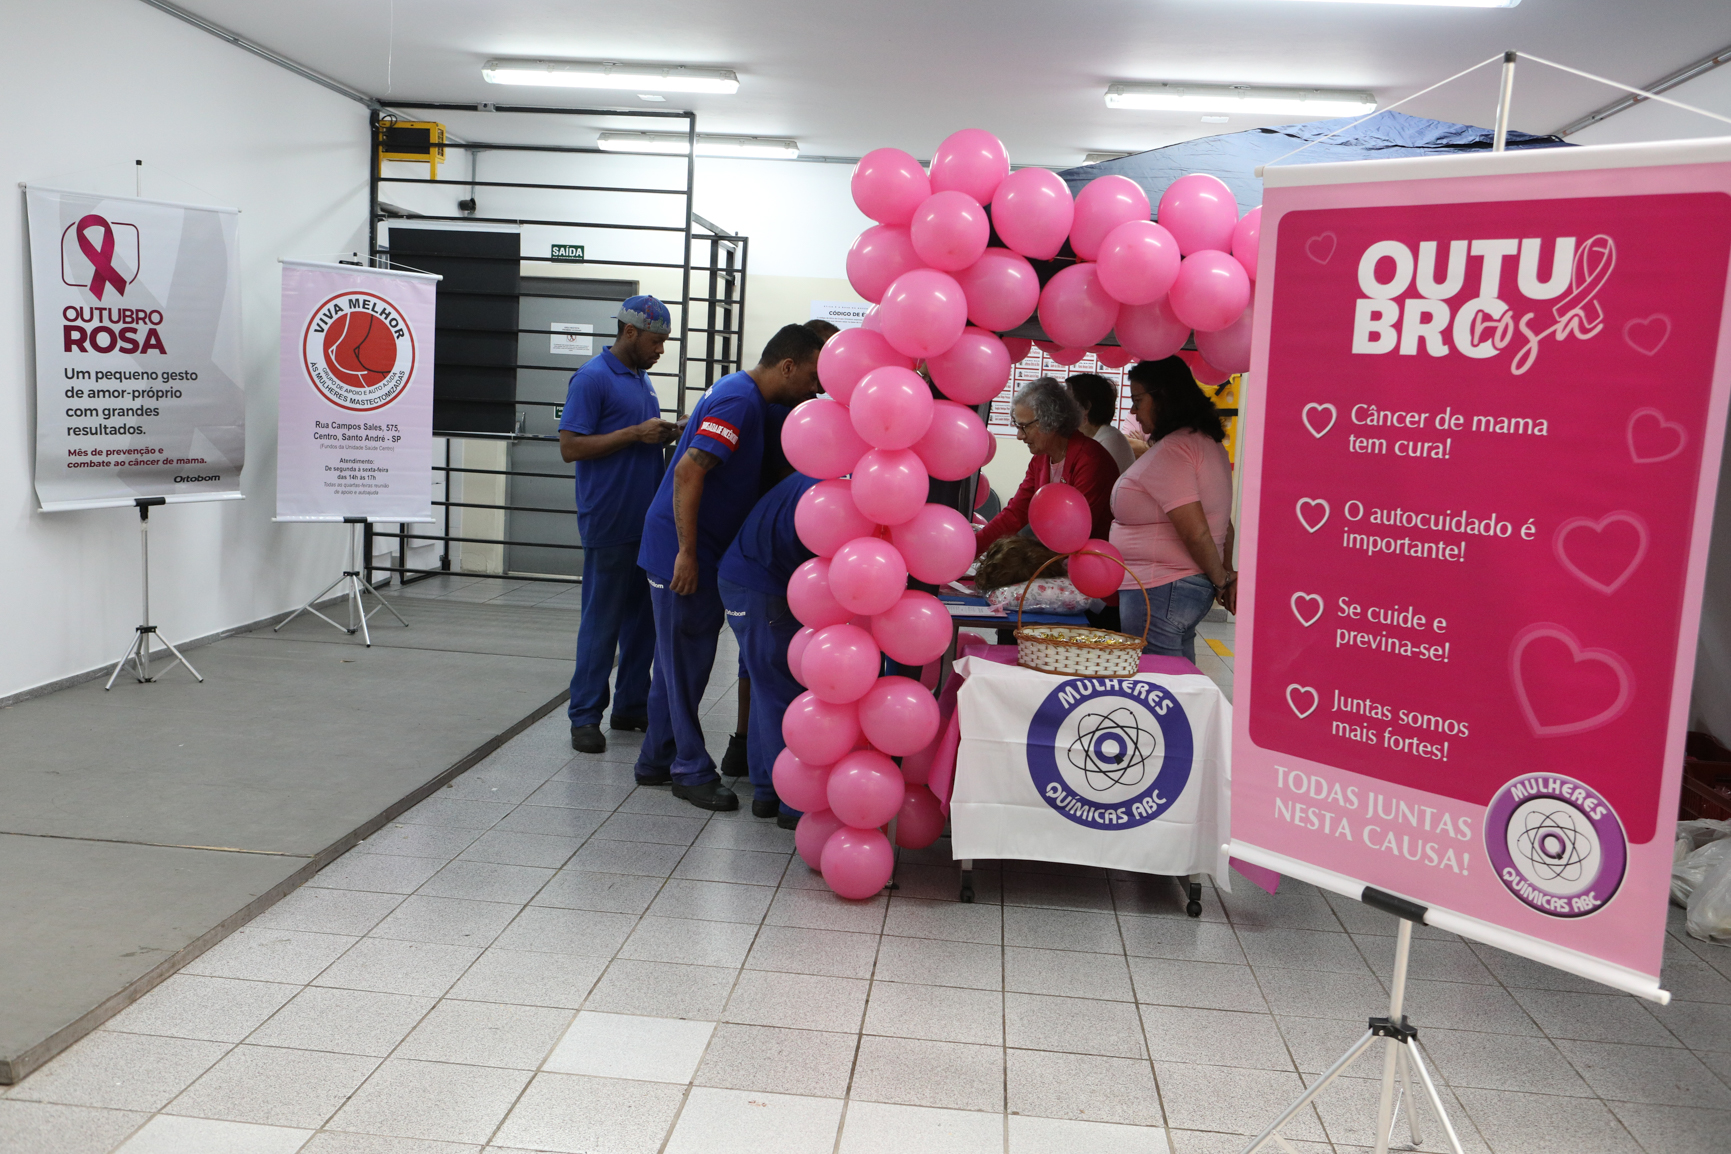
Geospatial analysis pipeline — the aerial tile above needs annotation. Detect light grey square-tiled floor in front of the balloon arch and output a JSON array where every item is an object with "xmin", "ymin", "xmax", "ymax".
[{"xmin": 0, "ymin": 591, "xmax": 1731, "ymax": 1154}]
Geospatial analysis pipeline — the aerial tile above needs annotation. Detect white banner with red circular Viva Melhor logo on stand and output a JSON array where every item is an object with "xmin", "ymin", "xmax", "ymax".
[{"xmin": 277, "ymin": 260, "xmax": 438, "ymax": 521}]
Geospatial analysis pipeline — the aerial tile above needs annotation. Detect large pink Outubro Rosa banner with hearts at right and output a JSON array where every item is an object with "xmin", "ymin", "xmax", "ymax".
[{"xmin": 1232, "ymin": 140, "xmax": 1731, "ymax": 1002}]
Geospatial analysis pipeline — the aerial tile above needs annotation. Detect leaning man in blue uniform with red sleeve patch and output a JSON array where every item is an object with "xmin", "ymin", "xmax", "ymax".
[{"xmin": 637, "ymin": 325, "xmax": 824, "ymax": 810}]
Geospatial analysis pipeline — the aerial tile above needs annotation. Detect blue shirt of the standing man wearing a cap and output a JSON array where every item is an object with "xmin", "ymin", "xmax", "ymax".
[{"xmin": 559, "ymin": 349, "xmax": 661, "ymax": 548}]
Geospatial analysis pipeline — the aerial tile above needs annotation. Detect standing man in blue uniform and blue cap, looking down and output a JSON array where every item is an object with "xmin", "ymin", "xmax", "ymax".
[{"xmin": 559, "ymin": 296, "xmax": 679, "ymax": 753}]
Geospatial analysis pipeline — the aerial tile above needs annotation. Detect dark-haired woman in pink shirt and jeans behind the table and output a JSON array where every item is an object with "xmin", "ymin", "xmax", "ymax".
[{"xmin": 1111, "ymin": 356, "xmax": 1238, "ymax": 661}]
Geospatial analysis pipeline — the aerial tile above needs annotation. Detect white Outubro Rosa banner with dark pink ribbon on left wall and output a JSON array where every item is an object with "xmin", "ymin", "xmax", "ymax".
[{"xmin": 24, "ymin": 189, "xmax": 246, "ymax": 512}]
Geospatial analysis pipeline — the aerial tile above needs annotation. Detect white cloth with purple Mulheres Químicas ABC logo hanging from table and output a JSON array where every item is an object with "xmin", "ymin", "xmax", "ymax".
[{"xmin": 950, "ymin": 657, "xmax": 1232, "ymax": 886}]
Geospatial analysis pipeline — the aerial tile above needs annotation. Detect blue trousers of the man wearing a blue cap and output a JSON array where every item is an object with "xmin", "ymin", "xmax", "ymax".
[{"xmin": 566, "ymin": 542, "xmax": 654, "ymax": 725}]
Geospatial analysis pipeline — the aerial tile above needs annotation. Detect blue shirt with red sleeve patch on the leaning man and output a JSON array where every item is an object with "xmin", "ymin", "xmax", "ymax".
[{"xmin": 637, "ymin": 372, "xmax": 769, "ymax": 588}]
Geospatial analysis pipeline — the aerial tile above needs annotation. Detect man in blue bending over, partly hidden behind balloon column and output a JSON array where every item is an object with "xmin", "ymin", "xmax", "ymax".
[{"xmin": 718, "ymin": 467, "xmax": 817, "ymax": 829}]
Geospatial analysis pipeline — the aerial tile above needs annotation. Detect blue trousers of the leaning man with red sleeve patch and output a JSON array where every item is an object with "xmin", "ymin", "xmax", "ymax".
[{"xmin": 637, "ymin": 576, "xmax": 724, "ymax": 785}]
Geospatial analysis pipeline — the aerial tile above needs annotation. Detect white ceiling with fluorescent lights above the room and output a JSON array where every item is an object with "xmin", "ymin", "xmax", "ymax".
[{"xmin": 164, "ymin": 0, "xmax": 1731, "ymax": 166}]
